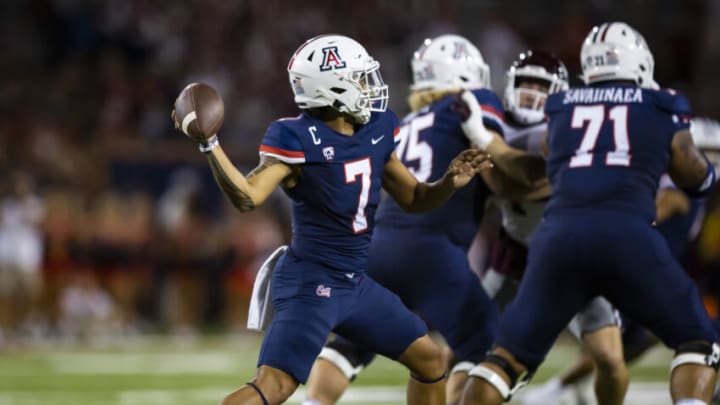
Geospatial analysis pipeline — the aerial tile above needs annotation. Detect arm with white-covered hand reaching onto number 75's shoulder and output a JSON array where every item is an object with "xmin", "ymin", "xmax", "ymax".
[{"xmin": 455, "ymin": 91, "xmax": 545, "ymax": 187}]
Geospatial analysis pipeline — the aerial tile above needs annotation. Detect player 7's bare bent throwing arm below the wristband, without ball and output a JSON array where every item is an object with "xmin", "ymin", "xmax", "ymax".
[{"xmin": 207, "ymin": 146, "xmax": 293, "ymax": 212}]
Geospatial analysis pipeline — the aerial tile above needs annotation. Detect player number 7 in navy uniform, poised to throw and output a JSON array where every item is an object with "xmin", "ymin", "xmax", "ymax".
[{"xmin": 173, "ymin": 35, "xmax": 488, "ymax": 405}]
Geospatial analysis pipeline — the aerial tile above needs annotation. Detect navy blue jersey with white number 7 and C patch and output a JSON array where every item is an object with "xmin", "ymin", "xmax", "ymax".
[{"xmin": 260, "ymin": 111, "xmax": 398, "ymax": 272}]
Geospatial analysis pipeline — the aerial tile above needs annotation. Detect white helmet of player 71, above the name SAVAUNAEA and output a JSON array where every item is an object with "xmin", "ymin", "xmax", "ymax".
[{"xmin": 580, "ymin": 22, "xmax": 659, "ymax": 89}]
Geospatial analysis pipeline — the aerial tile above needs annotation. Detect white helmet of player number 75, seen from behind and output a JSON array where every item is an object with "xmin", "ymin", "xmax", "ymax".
[{"xmin": 410, "ymin": 34, "xmax": 490, "ymax": 90}]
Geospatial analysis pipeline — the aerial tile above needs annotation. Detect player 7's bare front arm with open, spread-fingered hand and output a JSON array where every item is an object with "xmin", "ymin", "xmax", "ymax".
[{"xmin": 383, "ymin": 149, "xmax": 492, "ymax": 212}]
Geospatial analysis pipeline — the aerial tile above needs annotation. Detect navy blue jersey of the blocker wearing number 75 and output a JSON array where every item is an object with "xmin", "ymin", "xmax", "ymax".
[{"xmin": 377, "ymin": 89, "xmax": 503, "ymax": 248}]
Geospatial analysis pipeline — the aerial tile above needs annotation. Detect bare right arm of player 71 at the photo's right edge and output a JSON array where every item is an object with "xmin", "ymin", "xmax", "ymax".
[{"xmin": 668, "ymin": 129, "xmax": 715, "ymax": 197}]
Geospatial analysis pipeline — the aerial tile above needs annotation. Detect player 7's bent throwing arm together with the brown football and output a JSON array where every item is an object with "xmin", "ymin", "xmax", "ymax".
[{"xmin": 171, "ymin": 83, "xmax": 292, "ymax": 212}]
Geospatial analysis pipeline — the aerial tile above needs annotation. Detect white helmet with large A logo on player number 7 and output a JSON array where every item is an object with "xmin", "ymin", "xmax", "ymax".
[{"xmin": 288, "ymin": 35, "xmax": 388, "ymax": 124}]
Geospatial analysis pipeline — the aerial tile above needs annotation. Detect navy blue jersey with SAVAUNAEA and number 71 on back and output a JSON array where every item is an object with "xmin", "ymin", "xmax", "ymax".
[{"xmin": 545, "ymin": 83, "xmax": 691, "ymax": 220}]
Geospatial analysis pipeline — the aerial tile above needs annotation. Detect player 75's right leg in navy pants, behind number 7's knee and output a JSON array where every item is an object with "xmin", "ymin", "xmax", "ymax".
[{"xmin": 368, "ymin": 228, "xmax": 497, "ymax": 404}]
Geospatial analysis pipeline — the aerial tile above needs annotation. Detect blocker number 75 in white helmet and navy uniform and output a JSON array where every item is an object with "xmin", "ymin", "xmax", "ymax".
[{"xmin": 306, "ymin": 35, "xmax": 503, "ymax": 405}]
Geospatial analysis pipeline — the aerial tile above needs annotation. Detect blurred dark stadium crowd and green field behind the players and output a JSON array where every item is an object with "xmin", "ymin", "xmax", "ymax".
[{"xmin": 0, "ymin": 0, "xmax": 720, "ymax": 405}]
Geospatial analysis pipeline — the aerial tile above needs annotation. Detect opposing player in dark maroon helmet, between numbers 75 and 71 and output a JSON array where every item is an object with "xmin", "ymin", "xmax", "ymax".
[{"xmin": 483, "ymin": 50, "xmax": 628, "ymax": 405}]
